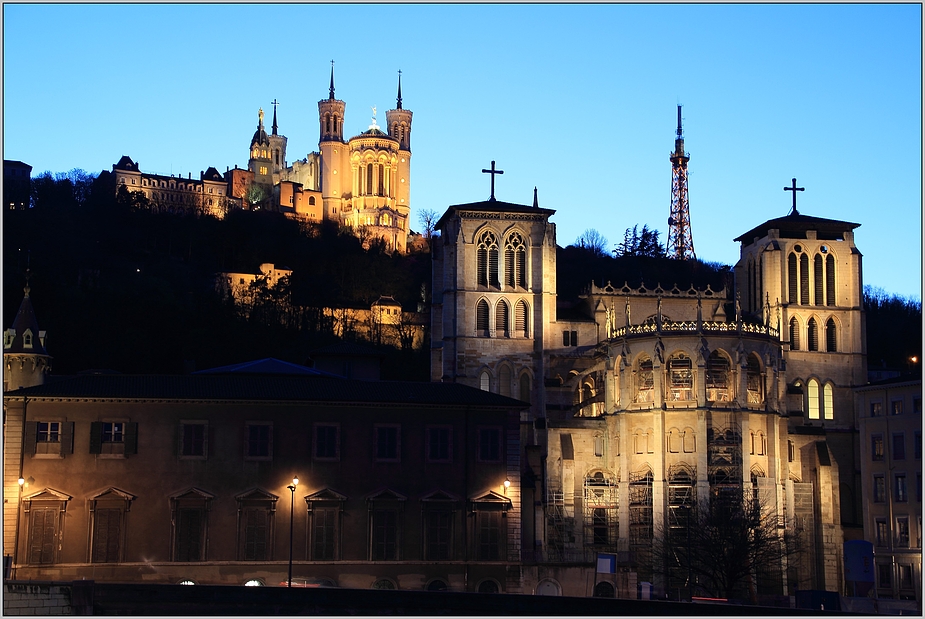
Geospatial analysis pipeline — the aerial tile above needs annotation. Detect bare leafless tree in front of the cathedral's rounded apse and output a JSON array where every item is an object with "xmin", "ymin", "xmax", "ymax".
[{"xmin": 653, "ymin": 485, "xmax": 803, "ymax": 602}]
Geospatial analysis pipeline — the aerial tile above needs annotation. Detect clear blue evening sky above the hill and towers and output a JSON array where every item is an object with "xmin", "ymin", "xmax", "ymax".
[{"xmin": 3, "ymin": 4, "xmax": 922, "ymax": 301}]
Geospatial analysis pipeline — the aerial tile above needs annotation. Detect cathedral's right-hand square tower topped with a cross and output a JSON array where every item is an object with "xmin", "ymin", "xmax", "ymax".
[{"xmin": 735, "ymin": 193, "xmax": 867, "ymax": 524}]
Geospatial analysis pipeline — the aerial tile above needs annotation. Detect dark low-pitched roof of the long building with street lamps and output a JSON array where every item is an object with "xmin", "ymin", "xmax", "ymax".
[{"xmin": 4, "ymin": 374, "xmax": 528, "ymax": 408}]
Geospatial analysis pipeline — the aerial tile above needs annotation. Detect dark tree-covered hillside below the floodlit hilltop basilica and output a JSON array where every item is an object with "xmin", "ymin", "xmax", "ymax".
[{"xmin": 3, "ymin": 170, "xmax": 430, "ymax": 380}]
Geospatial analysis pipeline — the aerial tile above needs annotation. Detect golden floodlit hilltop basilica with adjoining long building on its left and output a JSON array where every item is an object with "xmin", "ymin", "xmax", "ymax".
[{"xmin": 113, "ymin": 66, "xmax": 412, "ymax": 252}]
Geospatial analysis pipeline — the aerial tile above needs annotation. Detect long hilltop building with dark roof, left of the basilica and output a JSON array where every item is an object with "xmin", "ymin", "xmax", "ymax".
[{"xmin": 112, "ymin": 155, "xmax": 241, "ymax": 218}]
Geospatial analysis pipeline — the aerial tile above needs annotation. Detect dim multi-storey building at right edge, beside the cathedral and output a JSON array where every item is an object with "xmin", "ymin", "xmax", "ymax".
[{"xmin": 854, "ymin": 374, "xmax": 922, "ymax": 613}]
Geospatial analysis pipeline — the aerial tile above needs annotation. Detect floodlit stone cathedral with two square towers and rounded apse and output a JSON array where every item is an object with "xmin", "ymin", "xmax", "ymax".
[{"xmin": 431, "ymin": 179, "xmax": 866, "ymax": 597}]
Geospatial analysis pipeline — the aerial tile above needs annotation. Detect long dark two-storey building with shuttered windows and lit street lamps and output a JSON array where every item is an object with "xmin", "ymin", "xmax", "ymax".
[{"xmin": 4, "ymin": 334, "xmax": 523, "ymax": 593}]
